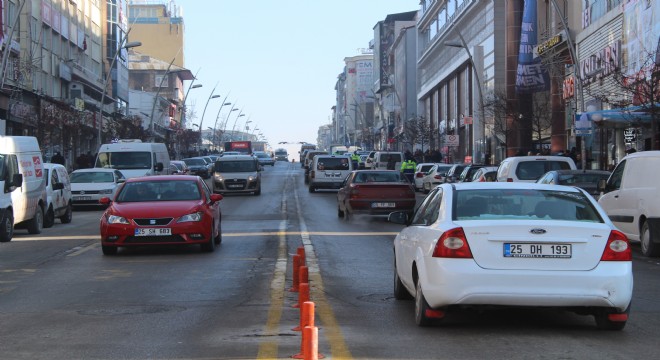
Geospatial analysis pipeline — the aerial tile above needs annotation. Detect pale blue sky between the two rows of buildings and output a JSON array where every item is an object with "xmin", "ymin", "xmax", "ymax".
[{"xmin": 176, "ymin": 0, "xmax": 419, "ymax": 146}]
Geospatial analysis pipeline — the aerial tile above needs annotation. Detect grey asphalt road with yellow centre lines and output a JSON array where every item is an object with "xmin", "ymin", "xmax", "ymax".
[{"xmin": 0, "ymin": 162, "xmax": 660, "ymax": 360}]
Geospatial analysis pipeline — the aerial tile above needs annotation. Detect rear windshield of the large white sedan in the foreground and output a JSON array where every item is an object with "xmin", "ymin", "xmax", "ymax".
[{"xmin": 453, "ymin": 189, "xmax": 603, "ymax": 223}]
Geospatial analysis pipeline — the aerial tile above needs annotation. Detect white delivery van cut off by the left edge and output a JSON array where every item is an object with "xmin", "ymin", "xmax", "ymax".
[{"xmin": 0, "ymin": 136, "xmax": 46, "ymax": 241}]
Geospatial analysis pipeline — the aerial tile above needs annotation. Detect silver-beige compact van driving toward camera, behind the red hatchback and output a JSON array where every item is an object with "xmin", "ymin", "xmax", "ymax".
[{"xmin": 213, "ymin": 155, "xmax": 261, "ymax": 195}]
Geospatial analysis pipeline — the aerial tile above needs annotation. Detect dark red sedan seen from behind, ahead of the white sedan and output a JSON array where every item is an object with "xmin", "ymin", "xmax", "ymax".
[{"xmin": 337, "ymin": 170, "xmax": 415, "ymax": 220}]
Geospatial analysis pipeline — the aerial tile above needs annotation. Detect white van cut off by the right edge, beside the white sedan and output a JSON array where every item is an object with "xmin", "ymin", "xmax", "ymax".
[{"xmin": 598, "ymin": 151, "xmax": 660, "ymax": 257}]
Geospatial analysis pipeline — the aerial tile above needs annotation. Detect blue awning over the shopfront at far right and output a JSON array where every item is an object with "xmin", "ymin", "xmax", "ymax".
[{"xmin": 576, "ymin": 103, "xmax": 660, "ymax": 128}]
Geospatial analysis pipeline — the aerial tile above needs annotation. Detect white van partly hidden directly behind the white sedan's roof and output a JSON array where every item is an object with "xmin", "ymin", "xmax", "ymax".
[{"xmin": 497, "ymin": 155, "xmax": 577, "ymax": 182}]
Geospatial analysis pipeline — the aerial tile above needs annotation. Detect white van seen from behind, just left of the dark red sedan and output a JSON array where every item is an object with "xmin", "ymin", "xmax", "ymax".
[{"xmin": 309, "ymin": 155, "xmax": 353, "ymax": 192}]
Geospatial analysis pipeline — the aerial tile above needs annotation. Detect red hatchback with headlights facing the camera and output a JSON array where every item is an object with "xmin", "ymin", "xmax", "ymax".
[{"xmin": 100, "ymin": 175, "xmax": 222, "ymax": 255}]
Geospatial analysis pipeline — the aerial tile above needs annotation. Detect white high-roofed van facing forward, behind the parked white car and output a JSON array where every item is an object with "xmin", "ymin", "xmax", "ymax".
[{"xmin": 94, "ymin": 140, "xmax": 170, "ymax": 179}]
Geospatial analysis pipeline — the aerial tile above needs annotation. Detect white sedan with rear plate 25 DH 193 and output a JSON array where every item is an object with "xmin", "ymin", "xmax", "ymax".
[{"xmin": 389, "ymin": 182, "xmax": 633, "ymax": 330}]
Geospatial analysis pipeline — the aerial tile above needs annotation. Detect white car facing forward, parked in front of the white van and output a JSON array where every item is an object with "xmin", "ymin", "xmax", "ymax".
[{"xmin": 71, "ymin": 168, "xmax": 126, "ymax": 206}]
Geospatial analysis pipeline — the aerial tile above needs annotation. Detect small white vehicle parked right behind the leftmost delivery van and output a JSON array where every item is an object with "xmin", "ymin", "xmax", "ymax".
[{"xmin": 44, "ymin": 163, "xmax": 73, "ymax": 228}]
